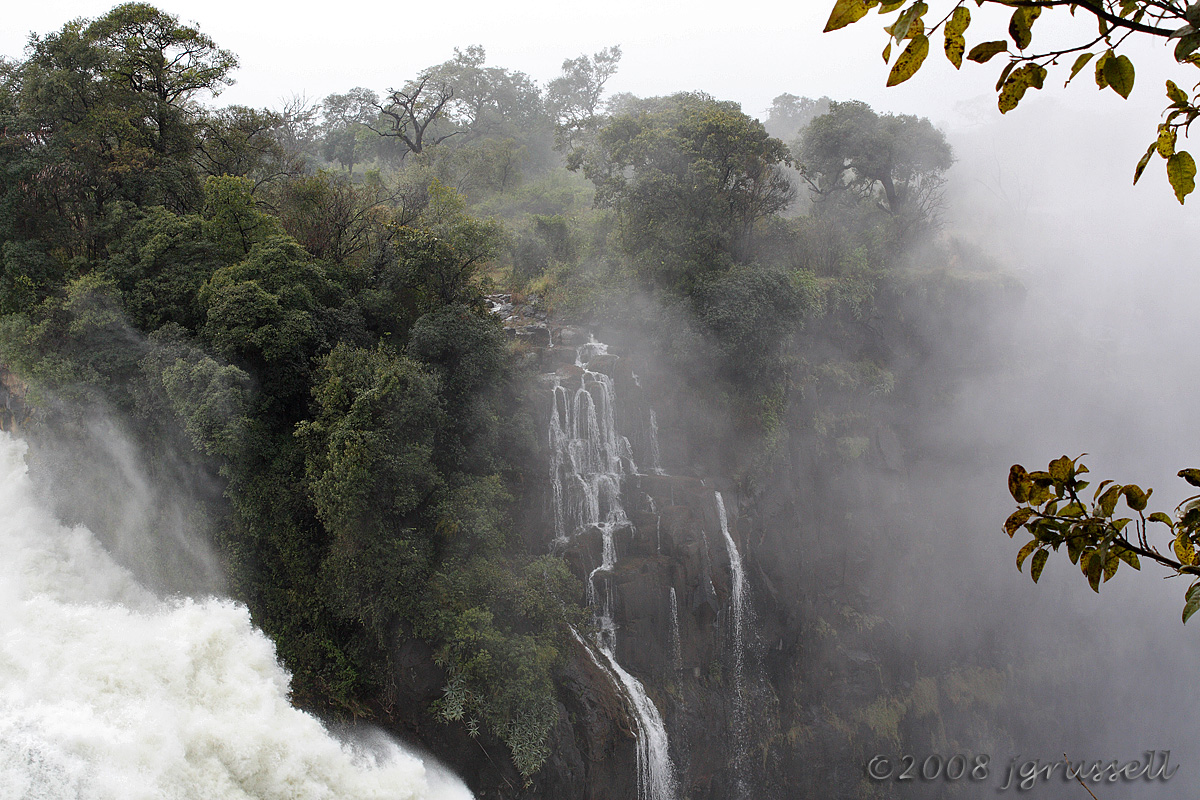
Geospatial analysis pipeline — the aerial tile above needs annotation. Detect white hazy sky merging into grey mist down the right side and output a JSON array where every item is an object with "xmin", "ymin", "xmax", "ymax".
[{"xmin": 0, "ymin": 0, "xmax": 1200, "ymax": 798}]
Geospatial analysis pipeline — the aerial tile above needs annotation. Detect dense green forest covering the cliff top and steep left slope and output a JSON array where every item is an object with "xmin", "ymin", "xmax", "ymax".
[{"xmin": 0, "ymin": 4, "xmax": 1010, "ymax": 780}]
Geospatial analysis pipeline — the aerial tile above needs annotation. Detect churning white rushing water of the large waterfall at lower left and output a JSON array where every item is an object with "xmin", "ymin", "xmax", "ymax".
[{"xmin": 0, "ymin": 432, "xmax": 470, "ymax": 800}]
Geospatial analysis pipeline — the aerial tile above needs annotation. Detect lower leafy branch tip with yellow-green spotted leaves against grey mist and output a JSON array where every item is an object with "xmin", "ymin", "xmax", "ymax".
[{"xmin": 1004, "ymin": 456, "xmax": 1200, "ymax": 622}]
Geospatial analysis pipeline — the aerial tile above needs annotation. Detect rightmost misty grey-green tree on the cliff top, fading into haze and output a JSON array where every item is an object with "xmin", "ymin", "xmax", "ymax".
[{"xmin": 799, "ymin": 101, "xmax": 954, "ymax": 230}]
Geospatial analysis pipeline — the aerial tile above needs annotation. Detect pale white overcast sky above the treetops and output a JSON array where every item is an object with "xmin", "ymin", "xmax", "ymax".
[{"xmin": 0, "ymin": 0, "xmax": 1168, "ymax": 136}]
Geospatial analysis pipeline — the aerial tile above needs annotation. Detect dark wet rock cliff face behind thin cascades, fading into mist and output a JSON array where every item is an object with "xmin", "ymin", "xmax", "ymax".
[{"xmin": 501, "ymin": 302, "xmax": 937, "ymax": 800}]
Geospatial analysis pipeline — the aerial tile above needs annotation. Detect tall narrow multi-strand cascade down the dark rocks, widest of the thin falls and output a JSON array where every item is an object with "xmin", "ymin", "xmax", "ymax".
[{"xmin": 550, "ymin": 339, "xmax": 678, "ymax": 800}]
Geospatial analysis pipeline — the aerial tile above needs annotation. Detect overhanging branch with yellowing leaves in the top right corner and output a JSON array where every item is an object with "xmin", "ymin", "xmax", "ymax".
[{"xmin": 826, "ymin": 0, "xmax": 1200, "ymax": 203}]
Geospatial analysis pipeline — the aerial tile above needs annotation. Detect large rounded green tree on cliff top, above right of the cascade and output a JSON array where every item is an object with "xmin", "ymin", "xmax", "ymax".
[{"xmin": 582, "ymin": 94, "xmax": 794, "ymax": 285}]
